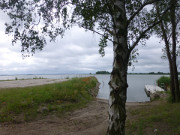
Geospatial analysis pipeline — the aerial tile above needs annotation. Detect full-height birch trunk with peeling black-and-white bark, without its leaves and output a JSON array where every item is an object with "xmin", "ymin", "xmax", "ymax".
[{"xmin": 107, "ymin": 0, "xmax": 129, "ymax": 135}]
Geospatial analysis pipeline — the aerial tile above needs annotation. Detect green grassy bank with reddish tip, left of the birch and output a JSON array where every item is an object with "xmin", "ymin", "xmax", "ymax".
[{"xmin": 0, "ymin": 77, "xmax": 97, "ymax": 122}]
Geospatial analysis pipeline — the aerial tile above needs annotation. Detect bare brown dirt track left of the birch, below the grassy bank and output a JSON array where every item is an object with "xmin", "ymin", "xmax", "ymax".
[{"xmin": 0, "ymin": 100, "xmax": 108, "ymax": 135}]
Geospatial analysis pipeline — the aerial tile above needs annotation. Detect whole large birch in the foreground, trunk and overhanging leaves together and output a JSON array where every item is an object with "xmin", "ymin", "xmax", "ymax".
[{"xmin": 0, "ymin": 0, "xmax": 168, "ymax": 135}]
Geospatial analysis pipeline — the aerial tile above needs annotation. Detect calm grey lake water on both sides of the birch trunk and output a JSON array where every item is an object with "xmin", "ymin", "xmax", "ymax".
[{"xmin": 0, "ymin": 74, "xmax": 167, "ymax": 102}]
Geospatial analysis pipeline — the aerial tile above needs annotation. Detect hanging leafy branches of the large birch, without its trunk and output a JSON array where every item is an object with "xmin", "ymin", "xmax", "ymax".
[{"xmin": 0, "ymin": 0, "xmax": 163, "ymax": 59}]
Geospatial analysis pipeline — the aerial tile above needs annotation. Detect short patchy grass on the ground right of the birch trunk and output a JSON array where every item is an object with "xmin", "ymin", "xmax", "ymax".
[{"xmin": 126, "ymin": 101, "xmax": 180, "ymax": 135}]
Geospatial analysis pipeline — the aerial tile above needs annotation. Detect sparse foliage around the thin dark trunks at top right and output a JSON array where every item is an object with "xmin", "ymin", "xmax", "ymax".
[{"xmin": 154, "ymin": 0, "xmax": 180, "ymax": 59}]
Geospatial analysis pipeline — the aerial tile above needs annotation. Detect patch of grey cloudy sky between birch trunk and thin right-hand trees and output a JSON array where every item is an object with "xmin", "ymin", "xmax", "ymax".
[{"xmin": 129, "ymin": 36, "xmax": 169, "ymax": 73}]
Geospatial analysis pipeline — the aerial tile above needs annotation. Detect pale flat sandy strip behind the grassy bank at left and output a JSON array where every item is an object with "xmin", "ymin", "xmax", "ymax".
[{"xmin": 0, "ymin": 79, "xmax": 67, "ymax": 89}]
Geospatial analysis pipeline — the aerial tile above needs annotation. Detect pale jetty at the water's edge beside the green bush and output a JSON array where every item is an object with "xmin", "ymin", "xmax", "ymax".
[{"xmin": 144, "ymin": 85, "xmax": 165, "ymax": 100}]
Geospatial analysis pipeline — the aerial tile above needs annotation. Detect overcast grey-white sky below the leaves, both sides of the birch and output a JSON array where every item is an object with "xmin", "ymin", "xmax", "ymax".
[{"xmin": 0, "ymin": 12, "xmax": 169, "ymax": 75}]
